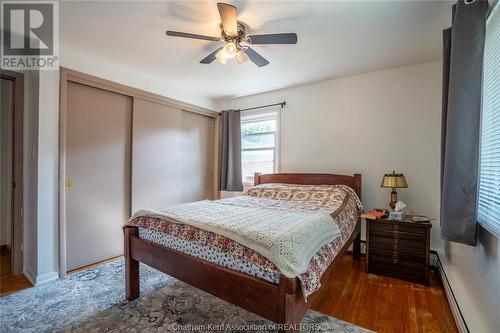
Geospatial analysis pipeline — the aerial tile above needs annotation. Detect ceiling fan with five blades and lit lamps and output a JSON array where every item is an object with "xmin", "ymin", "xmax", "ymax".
[{"xmin": 167, "ymin": 2, "xmax": 297, "ymax": 67}]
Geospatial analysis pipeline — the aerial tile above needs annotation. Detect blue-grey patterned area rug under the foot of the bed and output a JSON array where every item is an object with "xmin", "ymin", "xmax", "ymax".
[{"xmin": 0, "ymin": 260, "xmax": 368, "ymax": 333}]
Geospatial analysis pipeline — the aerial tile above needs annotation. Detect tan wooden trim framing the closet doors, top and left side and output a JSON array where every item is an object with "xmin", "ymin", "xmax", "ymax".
[{"xmin": 59, "ymin": 67, "xmax": 219, "ymax": 277}]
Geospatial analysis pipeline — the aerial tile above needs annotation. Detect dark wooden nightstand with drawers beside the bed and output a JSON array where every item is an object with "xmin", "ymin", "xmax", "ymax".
[{"xmin": 366, "ymin": 216, "xmax": 432, "ymax": 285}]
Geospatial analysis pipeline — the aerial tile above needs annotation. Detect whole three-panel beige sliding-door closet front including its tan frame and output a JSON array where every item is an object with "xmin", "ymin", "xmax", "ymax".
[{"xmin": 60, "ymin": 69, "xmax": 215, "ymax": 274}]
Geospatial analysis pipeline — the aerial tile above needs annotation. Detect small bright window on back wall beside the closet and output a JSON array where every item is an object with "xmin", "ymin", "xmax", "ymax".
[{"xmin": 241, "ymin": 111, "xmax": 279, "ymax": 184}]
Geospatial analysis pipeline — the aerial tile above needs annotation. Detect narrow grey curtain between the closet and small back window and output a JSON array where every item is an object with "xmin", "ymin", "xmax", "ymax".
[{"xmin": 219, "ymin": 110, "xmax": 243, "ymax": 191}]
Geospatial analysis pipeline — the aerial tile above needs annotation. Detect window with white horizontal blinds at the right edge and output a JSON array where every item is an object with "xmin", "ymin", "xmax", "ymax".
[{"xmin": 478, "ymin": 3, "xmax": 500, "ymax": 236}]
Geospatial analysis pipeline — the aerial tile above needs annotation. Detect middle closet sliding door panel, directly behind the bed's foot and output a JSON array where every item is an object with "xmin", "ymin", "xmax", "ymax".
[{"xmin": 132, "ymin": 98, "xmax": 183, "ymax": 212}]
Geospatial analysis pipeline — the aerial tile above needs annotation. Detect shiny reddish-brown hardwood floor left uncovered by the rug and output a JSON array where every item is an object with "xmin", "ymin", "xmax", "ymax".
[{"xmin": 0, "ymin": 249, "xmax": 457, "ymax": 333}]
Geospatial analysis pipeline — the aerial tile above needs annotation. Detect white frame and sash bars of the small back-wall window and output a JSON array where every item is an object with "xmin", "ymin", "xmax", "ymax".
[{"xmin": 240, "ymin": 107, "xmax": 281, "ymax": 187}]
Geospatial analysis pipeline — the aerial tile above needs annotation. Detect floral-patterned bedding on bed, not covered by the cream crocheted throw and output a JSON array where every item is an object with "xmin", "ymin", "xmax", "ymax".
[{"xmin": 129, "ymin": 184, "xmax": 362, "ymax": 298}]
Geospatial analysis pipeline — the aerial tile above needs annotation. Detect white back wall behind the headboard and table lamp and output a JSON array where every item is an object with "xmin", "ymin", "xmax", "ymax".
[{"xmin": 220, "ymin": 61, "xmax": 441, "ymax": 247}]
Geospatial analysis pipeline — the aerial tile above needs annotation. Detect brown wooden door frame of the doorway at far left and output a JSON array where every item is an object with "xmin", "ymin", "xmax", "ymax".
[{"xmin": 0, "ymin": 69, "xmax": 24, "ymax": 276}]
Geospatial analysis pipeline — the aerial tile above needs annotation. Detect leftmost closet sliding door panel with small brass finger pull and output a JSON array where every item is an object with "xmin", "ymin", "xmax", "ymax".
[{"xmin": 65, "ymin": 82, "xmax": 132, "ymax": 271}]
